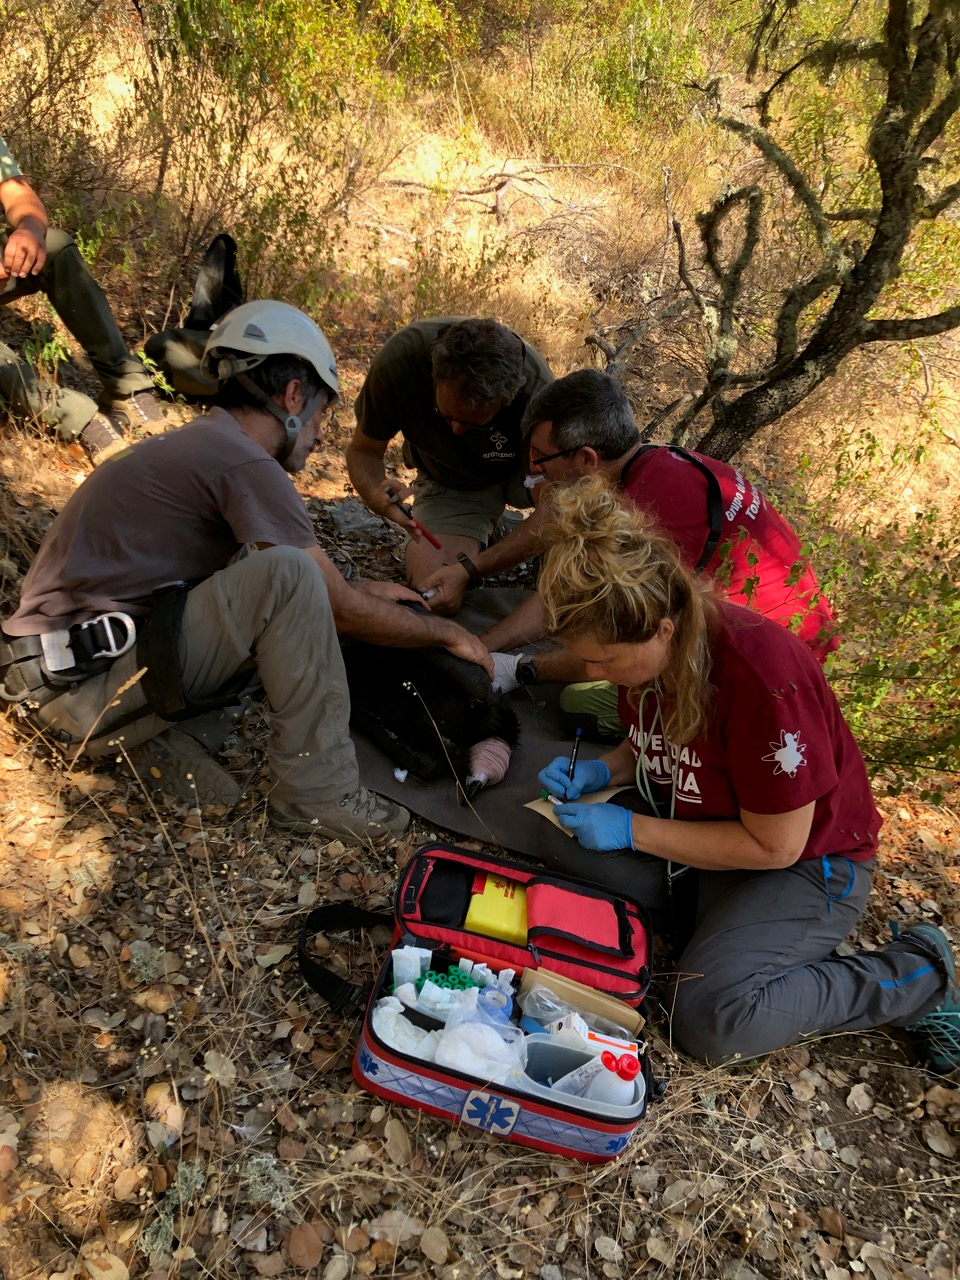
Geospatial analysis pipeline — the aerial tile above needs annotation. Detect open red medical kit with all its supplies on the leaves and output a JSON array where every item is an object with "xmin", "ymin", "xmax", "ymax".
[{"xmin": 298, "ymin": 845, "xmax": 659, "ymax": 1164}]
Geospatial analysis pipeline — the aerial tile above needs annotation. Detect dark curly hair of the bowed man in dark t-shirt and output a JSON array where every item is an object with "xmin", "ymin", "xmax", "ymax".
[{"xmin": 433, "ymin": 320, "xmax": 524, "ymax": 410}]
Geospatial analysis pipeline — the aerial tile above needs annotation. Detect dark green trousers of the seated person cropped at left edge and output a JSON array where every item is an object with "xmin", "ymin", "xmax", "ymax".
[{"xmin": 0, "ymin": 230, "xmax": 154, "ymax": 439}]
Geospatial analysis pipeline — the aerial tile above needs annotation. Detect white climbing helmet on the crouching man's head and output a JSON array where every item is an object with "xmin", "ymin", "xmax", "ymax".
[{"xmin": 200, "ymin": 300, "xmax": 340, "ymax": 397}]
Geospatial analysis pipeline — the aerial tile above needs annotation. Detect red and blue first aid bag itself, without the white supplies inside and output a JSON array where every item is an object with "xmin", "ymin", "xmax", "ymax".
[{"xmin": 298, "ymin": 845, "xmax": 662, "ymax": 1162}]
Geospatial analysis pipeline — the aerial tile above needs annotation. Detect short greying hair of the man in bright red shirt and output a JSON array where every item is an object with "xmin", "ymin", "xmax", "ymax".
[{"xmin": 524, "ymin": 369, "xmax": 640, "ymax": 462}]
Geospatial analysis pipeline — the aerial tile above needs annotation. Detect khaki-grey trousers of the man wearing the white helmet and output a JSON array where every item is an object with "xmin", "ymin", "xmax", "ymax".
[{"xmin": 35, "ymin": 547, "xmax": 360, "ymax": 809}]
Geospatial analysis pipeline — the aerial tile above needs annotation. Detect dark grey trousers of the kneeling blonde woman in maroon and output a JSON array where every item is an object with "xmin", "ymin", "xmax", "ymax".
[{"xmin": 538, "ymin": 788, "xmax": 946, "ymax": 1062}]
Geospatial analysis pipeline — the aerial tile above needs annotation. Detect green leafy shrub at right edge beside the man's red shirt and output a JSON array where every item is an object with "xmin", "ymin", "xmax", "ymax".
[{"xmin": 781, "ymin": 407, "xmax": 960, "ymax": 800}]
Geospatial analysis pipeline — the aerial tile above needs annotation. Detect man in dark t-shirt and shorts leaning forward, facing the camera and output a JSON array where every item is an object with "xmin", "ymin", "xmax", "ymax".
[{"xmin": 347, "ymin": 317, "xmax": 553, "ymax": 612}]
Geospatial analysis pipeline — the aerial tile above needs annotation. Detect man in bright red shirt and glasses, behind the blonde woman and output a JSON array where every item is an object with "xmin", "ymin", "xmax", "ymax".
[{"xmin": 422, "ymin": 369, "xmax": 840, "ymax": 687}]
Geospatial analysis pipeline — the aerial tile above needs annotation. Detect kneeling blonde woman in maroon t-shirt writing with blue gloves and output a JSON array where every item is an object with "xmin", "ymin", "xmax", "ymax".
[{"xmin": 539, "ymin": 479, "xmax": 960, "ymax": 1070}]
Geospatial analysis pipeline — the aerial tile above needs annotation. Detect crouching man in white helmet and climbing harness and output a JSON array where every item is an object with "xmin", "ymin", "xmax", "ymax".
[{"xmin": 0, "ymin": 302, "xmax": 492, "ymax": 840}]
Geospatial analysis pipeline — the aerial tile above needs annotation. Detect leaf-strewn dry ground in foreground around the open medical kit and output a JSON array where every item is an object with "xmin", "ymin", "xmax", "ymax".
[{"xmin": 0, "ymin": 711, "xmax": 960, "ymax": 1280}]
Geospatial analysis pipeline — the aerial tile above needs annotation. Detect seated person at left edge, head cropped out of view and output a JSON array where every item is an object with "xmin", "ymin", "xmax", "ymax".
[{"xmin": 0, "ymin": 138, "xmax": 164, "ymax": 462}]
